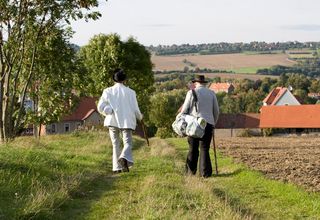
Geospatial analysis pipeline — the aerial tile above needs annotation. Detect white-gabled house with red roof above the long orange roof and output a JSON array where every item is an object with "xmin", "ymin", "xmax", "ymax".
[{"xmin": 263, "ymin": 87, "xmax": 301, "ymax": 106}]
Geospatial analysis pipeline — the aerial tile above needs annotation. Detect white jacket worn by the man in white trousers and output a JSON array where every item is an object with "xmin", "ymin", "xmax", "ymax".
[{"xmin": 98, "ymin": 83, "xmax": 142, "ymax": 130}]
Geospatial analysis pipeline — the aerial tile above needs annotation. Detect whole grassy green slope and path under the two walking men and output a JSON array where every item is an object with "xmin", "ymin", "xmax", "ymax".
[{"xmin": 0, "ymin": 132, "xmax": 320, "ymax": 219}]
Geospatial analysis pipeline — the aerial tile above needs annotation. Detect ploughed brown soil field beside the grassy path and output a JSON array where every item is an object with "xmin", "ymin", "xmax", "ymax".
[{"xmin": 217, "ymin": 137, "xmax": 320, "ymax": 192}]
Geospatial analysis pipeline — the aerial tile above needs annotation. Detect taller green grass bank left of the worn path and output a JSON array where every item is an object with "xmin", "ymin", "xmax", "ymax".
[{"xmin": 0, "ymin": 133, "xmax": 111, "ymax": 219}]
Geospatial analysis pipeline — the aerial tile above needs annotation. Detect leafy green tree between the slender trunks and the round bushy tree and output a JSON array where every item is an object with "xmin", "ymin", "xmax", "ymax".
[{"xmin": 26, "ymin": 29, "xmax": 85, "ymax": 136}]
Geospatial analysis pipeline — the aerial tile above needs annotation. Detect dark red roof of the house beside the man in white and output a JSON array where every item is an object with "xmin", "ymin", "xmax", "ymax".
[{"xmin": 63, "ymin": 97, "xmax": 97, "ymax": 121}]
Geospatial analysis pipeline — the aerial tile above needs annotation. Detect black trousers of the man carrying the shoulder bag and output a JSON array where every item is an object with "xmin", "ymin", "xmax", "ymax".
[{"xmin": 186, "ymin": 124, "xmax": 213, "ymax": 177}]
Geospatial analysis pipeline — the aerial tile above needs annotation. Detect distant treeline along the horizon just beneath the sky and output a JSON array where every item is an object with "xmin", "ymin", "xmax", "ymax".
[{"xmin": 147, "ymin": 41, "xmax": 320, "ymax": 55}]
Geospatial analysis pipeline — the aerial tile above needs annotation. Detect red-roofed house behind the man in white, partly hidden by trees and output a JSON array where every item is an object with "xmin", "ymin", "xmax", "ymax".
[{"xmin": 41, "ymin": 97, "xmax": 103, "ymax": 135}]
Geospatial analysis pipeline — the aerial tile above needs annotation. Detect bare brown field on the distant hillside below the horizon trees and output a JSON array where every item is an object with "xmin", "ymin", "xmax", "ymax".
[{"xmin": 151, "ymin": 53, "xmax": 295, "ymax": 71}]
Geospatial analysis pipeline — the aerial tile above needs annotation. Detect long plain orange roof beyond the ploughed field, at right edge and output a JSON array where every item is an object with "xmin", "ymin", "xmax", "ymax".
[{"xmin": 260, "ymin": 105, "xmax": 320, "ymax": 128}]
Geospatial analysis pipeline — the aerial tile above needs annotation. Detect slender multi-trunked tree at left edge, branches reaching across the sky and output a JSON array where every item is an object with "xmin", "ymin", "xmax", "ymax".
[{"xmin": 0, "ymin": 0, "xmax": 105, "ymax": 142}]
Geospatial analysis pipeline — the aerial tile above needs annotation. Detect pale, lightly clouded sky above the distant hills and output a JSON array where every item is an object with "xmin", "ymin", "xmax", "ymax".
[{"xmin": 71, "ymin": 0, "xmax": 320, "ymax": 46}]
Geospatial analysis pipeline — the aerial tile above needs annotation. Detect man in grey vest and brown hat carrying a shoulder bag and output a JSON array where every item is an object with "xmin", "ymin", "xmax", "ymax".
[{"xmin": 181, "ymin": 75, "xmax": 219, "ymax": 178}]
